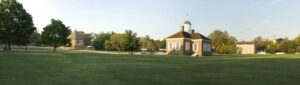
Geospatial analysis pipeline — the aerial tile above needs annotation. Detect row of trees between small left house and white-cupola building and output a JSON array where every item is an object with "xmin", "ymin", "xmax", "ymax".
[{"xmin": 91, "ymin": 30, "xmax": 166, "ymax": 52}]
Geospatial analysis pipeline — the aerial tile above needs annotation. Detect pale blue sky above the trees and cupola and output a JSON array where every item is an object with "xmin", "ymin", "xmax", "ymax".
[{"xmin": 19, "ymin": 0, "xmax": 300, "ymax": 40}]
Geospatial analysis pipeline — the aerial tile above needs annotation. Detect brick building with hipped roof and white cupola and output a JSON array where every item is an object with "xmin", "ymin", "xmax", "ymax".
[{"xmin": 166, "ymin": 20, "xmax": 212, "ymax": 56}]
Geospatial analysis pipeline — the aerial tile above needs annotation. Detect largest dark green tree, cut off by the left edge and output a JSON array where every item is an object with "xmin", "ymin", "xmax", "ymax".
[{"xmin": 0, "ymin": 0, "xmax": 36, "ymax": 51}]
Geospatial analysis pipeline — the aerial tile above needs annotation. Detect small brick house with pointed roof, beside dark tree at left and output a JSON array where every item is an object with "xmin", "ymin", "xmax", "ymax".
[{"xmin": 68, "ymin": 30, "xmax": 84, "ymax": 49}]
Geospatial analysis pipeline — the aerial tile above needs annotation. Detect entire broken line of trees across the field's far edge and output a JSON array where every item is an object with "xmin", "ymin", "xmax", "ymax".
[{"xmin": 0, "ymin": 0, "xmax": 300, "ymax": 54}]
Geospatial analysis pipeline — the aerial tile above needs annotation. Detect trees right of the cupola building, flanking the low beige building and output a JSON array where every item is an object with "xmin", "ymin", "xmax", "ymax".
[{"xmin": 209, "ymin": 30, "xmax": 300, "ymax": 54}]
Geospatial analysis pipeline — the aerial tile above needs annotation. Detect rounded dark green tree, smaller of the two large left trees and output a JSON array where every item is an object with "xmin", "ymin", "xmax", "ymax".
[{"xmin": 42, "ymin": 19, "xmax": 71, "ymax": 51}]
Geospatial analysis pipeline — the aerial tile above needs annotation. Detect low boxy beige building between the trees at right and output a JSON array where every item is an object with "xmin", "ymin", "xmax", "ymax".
[{"xmin": 236, "ymin": 42, "xmax": 256, "ymax": 54}]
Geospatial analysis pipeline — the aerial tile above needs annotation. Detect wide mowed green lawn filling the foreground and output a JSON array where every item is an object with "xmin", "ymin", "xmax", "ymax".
[{"xmin": 0, "ymin": 51, "xmax": 300, "ymax": 85}]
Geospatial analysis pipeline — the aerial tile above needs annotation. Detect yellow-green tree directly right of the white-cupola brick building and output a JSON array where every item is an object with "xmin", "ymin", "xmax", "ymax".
[{"xmin": 209, "ymin": 30, "xmax": 237, "ymax": 54}]
